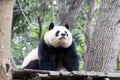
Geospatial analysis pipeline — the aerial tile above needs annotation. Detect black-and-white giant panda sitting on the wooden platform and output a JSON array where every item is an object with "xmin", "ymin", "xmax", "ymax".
[{"xmin": 23, "ymin": 23, "xmax": 79, "ymax": 71}]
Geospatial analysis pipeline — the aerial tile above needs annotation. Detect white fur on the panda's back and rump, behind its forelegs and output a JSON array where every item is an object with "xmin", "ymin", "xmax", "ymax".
[{"xmin": 22, "ymin": 47, "xmax": 38, "ymax": 68}]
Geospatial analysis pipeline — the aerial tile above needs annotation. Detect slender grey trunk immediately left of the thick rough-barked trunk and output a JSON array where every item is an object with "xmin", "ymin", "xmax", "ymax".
[{"xmin": 84, "ymin": 0, "xmax": 95, "ymax": 68}]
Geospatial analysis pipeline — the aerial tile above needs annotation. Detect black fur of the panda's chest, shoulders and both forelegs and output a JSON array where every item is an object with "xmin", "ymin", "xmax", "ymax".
[{"xmin": 39, "ymin": 37, "xmax": 79, "ymax": 71}]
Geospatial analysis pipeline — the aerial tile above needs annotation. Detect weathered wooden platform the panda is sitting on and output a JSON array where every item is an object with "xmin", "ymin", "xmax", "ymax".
[{"xmin": 13, "ymin": 69, "xmax": 120, "ymax": 80}]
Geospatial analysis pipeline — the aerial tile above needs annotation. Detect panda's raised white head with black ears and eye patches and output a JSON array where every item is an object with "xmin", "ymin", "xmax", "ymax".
[{"xmin": 44, "ymin": 23, "xmax": 72, "ymax": 48}]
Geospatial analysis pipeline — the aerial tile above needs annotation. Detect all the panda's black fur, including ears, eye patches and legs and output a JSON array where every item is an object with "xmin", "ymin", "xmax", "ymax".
[{"xmin": 24, "ymin": 23, "xmax": 79, "ymax": 71}]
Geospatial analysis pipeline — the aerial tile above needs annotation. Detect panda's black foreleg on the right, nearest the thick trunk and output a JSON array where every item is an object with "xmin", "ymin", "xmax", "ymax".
[{"xmin": 65, "ymin": 42, "xmax": 79, "ymax": 71}]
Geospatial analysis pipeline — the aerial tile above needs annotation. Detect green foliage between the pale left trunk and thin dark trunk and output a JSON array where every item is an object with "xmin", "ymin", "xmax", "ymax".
[{"xmin": 11, "ymin": 0, "xmax": 41, "ymax": 65}]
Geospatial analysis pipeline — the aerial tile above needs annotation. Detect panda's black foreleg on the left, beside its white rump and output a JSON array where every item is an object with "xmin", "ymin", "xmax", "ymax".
[{"xmin": 38, "ymin": 40, "xmax": 53, "ymax": 70}]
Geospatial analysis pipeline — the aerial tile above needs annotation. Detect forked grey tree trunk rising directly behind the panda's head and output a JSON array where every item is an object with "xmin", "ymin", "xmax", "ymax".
[{"xmin": 58, "ymin": 0, "xmax": 82, "ymax": 30}]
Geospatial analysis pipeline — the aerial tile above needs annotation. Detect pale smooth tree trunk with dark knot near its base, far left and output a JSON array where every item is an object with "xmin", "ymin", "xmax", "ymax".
[{"xmin": 0, "ymin": 0, "xmax": 14, "ymax": 80}]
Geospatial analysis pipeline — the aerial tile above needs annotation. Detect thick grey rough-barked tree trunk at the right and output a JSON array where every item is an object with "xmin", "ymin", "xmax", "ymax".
[{"xmin": 85, "ymin": 0, "xmax": 120, "ymax": 72}]
